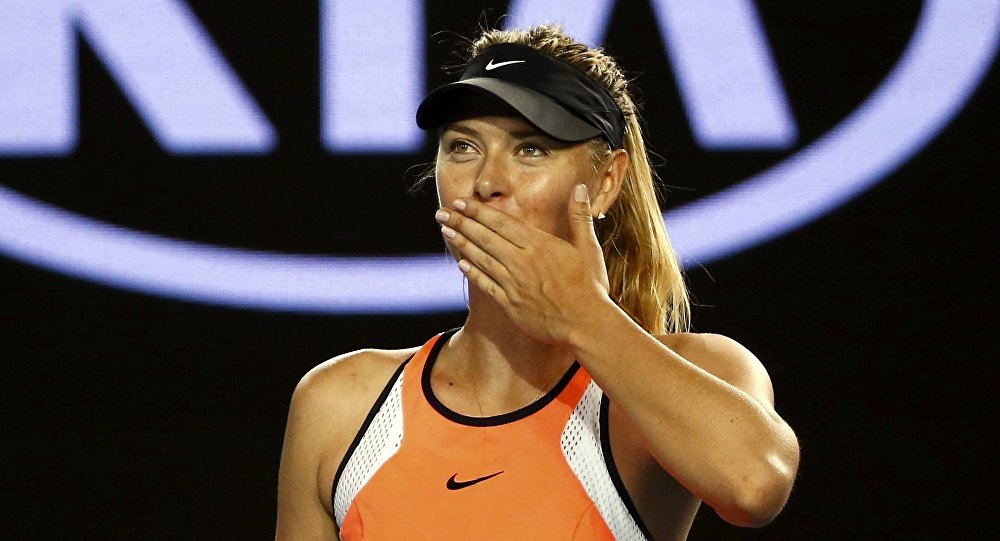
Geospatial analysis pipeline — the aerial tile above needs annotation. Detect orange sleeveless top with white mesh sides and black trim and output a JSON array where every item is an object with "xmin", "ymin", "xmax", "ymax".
[{"xmin": 333, "ymin": 330, "xmax": 649, "ymax": 541}]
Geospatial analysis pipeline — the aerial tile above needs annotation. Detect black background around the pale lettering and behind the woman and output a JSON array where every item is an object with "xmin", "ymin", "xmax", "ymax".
[{"xmin": 0, "ymin": 1, "xmax": 1000, "ymax": 540}]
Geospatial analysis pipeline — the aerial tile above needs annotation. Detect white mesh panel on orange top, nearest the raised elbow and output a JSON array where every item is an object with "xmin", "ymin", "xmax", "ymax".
[{"xmin": 562, "ymin": 381, "xmax": 646, "ymax": 541}]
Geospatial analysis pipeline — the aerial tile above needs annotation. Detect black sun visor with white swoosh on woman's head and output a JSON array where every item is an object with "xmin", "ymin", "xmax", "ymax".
[{"xmin": 417, "ymin": 43, "xmax": 625, "ymax": 148}]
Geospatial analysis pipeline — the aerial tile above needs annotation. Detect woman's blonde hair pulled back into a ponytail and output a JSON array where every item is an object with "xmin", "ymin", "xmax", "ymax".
[{"xmin": 466, "ymin": 25, "xmax": 691, "ymax": 334}]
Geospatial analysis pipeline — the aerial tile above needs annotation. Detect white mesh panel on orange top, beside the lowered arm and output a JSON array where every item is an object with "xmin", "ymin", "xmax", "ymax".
[{"xmin": 333, "ymin": 372, "xmax": 403, "ymax": 527}]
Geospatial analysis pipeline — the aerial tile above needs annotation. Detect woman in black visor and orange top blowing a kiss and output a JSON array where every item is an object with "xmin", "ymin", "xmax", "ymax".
[{"xmin": 277, "ymin": 26, "xmax": 799, "ymax": 540}]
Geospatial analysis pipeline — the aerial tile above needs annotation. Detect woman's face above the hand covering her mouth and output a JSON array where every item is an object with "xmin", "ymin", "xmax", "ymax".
[{"xmin": 435, "ymin": 116, "xmax": 598, "ymax": 243}]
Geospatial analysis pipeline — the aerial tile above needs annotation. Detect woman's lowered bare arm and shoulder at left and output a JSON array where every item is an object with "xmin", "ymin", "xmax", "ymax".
[{"xmin": 275, "ymin": 350, "xmax": 411, "ymax": 541}]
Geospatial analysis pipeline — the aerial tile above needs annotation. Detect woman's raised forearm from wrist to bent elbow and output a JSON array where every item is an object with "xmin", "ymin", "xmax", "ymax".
[{"xmin": 570, "ymin": 303, "xmax": 798, "ymax": 525}]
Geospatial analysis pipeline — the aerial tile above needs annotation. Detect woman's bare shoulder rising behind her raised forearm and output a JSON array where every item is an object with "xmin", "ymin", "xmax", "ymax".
[{"xmin": 657, "ymin": 333, "xmax": 774, "ymax": 405}]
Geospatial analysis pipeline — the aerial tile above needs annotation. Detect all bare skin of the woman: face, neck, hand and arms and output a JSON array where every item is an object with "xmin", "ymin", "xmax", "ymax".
[{"xmin": 276, "ymin": 116, "xmax": 799, "ymax": 540}]
